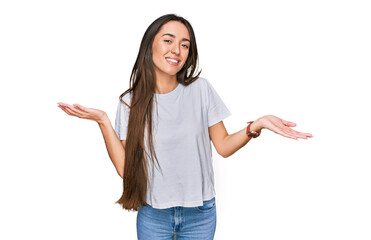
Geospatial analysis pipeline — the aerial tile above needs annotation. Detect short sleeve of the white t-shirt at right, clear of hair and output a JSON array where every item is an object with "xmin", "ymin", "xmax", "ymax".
[{"xmin": 205, "ymin": 79, "xmax": 232, "ymax": 127}]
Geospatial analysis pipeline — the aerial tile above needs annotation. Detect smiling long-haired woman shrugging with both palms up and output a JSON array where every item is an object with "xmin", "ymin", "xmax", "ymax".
[{"xmin": 59, "ymin": 14, "xmax": 312, "ymax": 240}]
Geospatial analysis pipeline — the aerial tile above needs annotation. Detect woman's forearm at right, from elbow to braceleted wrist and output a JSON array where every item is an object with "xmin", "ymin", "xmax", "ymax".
[{"xmin": 222, "ymin": 121, "xmax": 262, "ymax": 158}]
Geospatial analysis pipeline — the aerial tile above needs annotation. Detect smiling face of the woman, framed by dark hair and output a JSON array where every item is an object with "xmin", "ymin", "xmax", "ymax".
[{"xmin": 152, "ymin": 21, "xmax": 191, "ymax": 77}]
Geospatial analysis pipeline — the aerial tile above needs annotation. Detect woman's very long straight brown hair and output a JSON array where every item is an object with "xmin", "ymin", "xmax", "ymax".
[{"xmin": 115, "ymin": 14, "xmax": 201, "ymax": 211}]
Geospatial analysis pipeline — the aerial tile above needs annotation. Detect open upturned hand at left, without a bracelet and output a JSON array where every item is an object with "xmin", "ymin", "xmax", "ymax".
[{"xmin": 58, "ymin": 102, "xmax": 107, "ymax": 123}]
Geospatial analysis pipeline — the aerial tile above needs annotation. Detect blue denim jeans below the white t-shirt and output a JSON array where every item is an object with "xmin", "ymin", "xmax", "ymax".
[{"xmin": 137, "ymin": 197, "xmax": 216, "ymax": 240}]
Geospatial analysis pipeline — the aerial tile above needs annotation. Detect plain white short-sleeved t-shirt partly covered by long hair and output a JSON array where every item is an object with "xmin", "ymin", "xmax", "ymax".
[{"xmin": 115, "ymin": 77, "xmax": 231, "ymax": 209}]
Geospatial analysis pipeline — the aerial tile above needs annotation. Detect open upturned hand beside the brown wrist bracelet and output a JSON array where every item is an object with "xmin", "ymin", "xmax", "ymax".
[{"xmin": 251, "ymin": 115, "xmax": 313, "ymax": 140}]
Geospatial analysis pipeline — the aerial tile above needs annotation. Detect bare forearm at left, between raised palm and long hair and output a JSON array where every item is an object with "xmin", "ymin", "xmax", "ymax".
[{"xmin": 98, "ymin": 116, "xmax": 125, "ymax": 178}]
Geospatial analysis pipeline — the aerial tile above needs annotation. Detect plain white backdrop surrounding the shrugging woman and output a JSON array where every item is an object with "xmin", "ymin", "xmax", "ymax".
[{"xmin": 0, "ymin": 0, "xmax": 371, "ymax": 240}]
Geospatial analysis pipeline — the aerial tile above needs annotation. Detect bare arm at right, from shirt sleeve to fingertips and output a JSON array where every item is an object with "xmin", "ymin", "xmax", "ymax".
[{"xmin": 209, "ymin": 115, "xmax": 313, "ymax": 158}]
